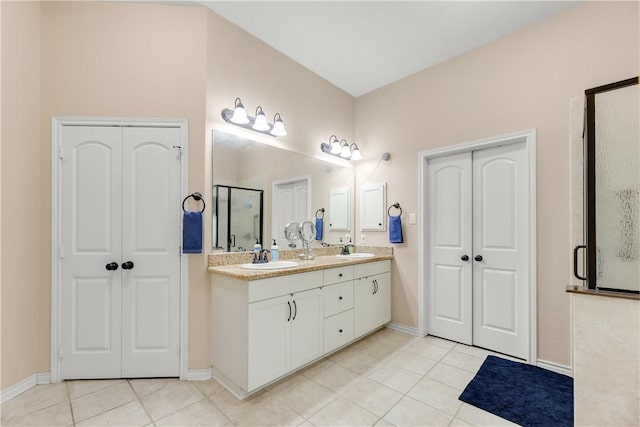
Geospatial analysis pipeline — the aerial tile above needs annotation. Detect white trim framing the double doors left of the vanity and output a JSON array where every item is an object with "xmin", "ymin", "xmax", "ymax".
[{"xmin": 51, "ymin": 116, "xmax": 189, "ymax": 382}]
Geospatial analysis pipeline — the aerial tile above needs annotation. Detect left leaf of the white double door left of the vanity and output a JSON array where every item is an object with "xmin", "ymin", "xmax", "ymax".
[{"xmin": 60, "ymin": 126, "xmax": 122, "ymax": 378}]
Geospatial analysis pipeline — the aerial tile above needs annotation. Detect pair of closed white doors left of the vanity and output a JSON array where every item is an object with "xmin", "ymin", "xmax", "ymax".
[{"xmin": 58, "ymin": 126, "xmax": 181, "ymax": 379}]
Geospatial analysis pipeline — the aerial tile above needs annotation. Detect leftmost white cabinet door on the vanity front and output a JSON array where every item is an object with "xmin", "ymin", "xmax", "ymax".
[{"xmin": 248, "ymin": 295, "xmax": 293, "ymax": 390}]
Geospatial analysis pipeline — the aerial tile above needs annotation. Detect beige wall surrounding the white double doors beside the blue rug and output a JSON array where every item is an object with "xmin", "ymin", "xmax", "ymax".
[{"xmin": 356, "ymin": 2, "xmax": 640, "ymax": 366}]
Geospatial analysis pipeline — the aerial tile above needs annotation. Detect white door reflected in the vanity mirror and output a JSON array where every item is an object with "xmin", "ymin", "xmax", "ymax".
[{"xmin": 271, "ymin": 176, "xmax": 311, "ymax": 248}]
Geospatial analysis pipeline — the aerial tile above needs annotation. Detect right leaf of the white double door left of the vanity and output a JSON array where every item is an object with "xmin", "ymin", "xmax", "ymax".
[{"xmin": 122, "ymin": 128, "xmax": 181, "ymax": 377}]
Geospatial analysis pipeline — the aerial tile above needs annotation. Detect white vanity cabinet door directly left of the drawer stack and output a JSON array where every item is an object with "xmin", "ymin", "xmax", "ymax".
[{"xmin": 290, "ymin": 289, "xmax": 323, "ymax": 369}]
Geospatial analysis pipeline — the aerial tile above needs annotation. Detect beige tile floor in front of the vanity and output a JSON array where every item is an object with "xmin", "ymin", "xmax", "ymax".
[{"xmin": 1, "ymin": 329, "xmax": 514, "ymax": 426}]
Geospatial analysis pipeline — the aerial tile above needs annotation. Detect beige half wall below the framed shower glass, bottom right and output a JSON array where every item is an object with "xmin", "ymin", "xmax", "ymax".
[{"xmin": 572, "ymin": 294, "xmax": 640, "ymax": 426}]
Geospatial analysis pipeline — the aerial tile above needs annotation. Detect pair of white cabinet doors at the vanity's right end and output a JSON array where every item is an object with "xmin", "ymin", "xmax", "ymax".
[{"xmin": 354, "ymin": 273, "xmax": 391, "ymax": 338}]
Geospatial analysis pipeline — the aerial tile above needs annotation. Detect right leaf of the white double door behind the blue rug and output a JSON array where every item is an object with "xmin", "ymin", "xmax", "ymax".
[{"xmin": 473, "ymin": 143, "xmax": 529, "ymax": 359}]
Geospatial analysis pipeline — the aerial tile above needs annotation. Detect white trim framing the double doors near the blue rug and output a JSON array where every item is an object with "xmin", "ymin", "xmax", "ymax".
[{"xmin": 418, "ymin": 129, "xmax": 538, "ymax": 364}]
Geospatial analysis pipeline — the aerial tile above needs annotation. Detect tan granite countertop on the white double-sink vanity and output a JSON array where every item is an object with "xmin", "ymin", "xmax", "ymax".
[{"xmin": 207, "ymin": 255, "xmax": 393, "ymax": 280}]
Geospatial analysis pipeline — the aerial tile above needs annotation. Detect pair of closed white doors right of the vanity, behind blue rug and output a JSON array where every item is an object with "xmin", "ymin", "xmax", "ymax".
[{"xmin": 427, "ymin": 142, "xmax": 530, "ymax": 359}]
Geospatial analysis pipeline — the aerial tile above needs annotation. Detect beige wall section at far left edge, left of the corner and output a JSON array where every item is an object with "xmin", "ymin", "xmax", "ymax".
[{"xmin": 0, "ymin": 2, "xmax": 42, "ymax": 390}]
